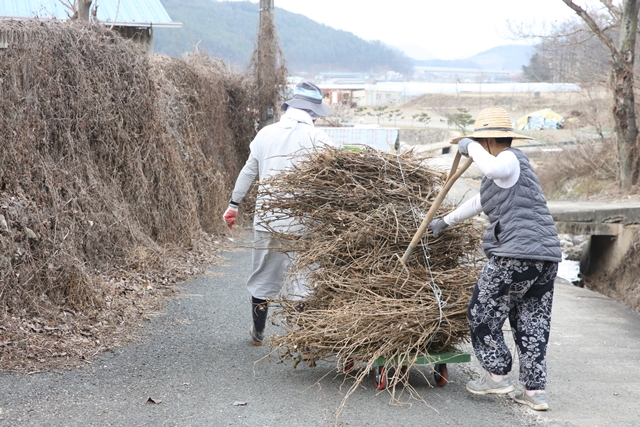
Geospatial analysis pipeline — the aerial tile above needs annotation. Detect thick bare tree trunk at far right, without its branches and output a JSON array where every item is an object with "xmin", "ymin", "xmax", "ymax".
[{"xmin": 611, "ymin": 0, "xmax": 640, "ymax": 188}]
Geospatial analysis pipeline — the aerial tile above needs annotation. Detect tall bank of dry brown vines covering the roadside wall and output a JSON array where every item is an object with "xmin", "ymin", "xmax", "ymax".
[{"xmin": 0, "ymin": 20, "xmax": 257, "ymax": 371}]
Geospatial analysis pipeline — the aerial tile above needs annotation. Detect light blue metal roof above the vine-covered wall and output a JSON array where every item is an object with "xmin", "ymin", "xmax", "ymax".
[{"xmin": 0, "ymin": 0, "xmax": 182, "ymax": 28}]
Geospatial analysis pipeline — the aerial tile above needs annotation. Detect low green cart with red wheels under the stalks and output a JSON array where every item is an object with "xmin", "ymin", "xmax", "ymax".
[{"xmin": 364, "ymin": 351, "xmax": 471, "ymax": 390}]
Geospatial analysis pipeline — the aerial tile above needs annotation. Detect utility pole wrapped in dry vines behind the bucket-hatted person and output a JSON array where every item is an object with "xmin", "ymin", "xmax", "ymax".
[{"xmin": 257, "ymin": 0, "xmax": 278, "ymax": 129}]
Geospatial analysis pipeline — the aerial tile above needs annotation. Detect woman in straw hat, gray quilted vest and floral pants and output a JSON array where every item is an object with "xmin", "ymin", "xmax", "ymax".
[{"xmin": 429, "ymin": 107, "xmax": 562, "ymax": 410}]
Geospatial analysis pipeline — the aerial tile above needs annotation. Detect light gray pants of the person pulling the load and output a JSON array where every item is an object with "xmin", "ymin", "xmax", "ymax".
[{"xmin": 247, "ymin": 230, "xmax": 308, "ymax": 299}]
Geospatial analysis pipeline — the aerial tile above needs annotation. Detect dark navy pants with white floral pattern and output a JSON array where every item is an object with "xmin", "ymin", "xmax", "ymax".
[{"xmin": 468, "ymin": 257, "xmax": 558, "ymax": 390}]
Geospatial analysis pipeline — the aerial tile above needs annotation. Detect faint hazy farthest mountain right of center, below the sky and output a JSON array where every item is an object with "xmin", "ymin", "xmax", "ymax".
[{"xmin": 416, "ymin": 44, "xmax": 533, "ymax": 71}]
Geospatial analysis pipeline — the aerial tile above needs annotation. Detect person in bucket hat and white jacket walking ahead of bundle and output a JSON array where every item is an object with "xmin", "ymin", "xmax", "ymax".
[{"xmin": 223, "ymin": 81, "xmax": 333, "ymax": 346}]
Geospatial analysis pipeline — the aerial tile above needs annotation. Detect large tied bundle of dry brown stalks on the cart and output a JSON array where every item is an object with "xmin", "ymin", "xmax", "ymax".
[{"xmin": 255, "ymin": 148, "xmax": 480, "ymax": 408}]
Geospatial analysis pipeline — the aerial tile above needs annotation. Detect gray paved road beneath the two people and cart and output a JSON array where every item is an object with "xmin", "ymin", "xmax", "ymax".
[{"xmin": 0, "ymin": 234, "xmax": 640, "ymax": 427}]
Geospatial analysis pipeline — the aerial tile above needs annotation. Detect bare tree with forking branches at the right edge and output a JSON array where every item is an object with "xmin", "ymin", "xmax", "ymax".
[{"xmin": 562, "ymin": 0, "xmax": 640, "ymax": 188}]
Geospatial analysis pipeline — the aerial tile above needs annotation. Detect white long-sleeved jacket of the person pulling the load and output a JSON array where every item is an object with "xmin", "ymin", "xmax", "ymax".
[{"xmin": 231, "ymin": 107, "xmax": 335, "ymax": 231}]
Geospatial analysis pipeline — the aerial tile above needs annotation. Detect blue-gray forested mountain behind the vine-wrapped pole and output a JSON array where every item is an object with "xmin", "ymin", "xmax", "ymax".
[{"xmin": 154, "ymin": 0, "xmax": 413, "ymax": 75}]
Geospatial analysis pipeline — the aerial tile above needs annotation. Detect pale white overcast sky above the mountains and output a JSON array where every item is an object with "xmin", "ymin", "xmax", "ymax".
[{"xmin": 236, "ymin": 0, "xmax": 604, "ymax": 59}]
